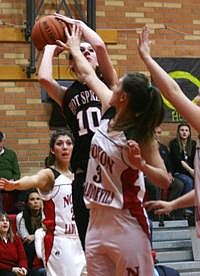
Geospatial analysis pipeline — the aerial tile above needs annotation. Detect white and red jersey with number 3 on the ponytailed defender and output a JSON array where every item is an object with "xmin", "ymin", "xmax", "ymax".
[{"xmin": 84, "ymin": 116, "xmax": 149, "ymax": 233}]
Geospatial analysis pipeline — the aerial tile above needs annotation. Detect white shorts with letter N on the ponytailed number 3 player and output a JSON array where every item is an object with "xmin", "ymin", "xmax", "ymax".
[{"xmin": 86, "ymin": 207, "xmax": 154, "ymax": 276}]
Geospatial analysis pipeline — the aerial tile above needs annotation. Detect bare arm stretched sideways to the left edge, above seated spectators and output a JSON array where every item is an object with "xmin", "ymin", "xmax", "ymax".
[{"xmin": 0, "ymin": 169, "xmax": 54, "ymax": 192}]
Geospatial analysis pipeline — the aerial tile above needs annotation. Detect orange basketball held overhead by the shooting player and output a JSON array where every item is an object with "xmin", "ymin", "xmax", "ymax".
[{"xmin": 31, "ymin": 15, "xmax": 66, "ymax": 50}]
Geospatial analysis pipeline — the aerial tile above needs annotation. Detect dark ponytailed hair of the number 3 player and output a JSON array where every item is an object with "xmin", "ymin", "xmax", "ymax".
[{"xmin": 122, "ymin": 73, "xmax": 164, "ymax": 142}]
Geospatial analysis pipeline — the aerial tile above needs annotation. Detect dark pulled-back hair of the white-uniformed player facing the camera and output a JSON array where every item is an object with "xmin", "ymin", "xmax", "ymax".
[{"xmin": 45, "ymin": 129, "xmax": 74, "ymax": 167}]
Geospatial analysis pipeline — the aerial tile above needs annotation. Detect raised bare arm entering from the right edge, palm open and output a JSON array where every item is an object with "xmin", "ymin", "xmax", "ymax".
[{"xmin": 138, "ymin": 26, "xmax": 200, "ymax": 132}]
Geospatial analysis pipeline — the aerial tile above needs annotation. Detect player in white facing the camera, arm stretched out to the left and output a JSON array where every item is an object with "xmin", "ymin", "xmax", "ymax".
[{"xmin": 0, "ymin": 130, "xmax": 86, "ymax": 276}]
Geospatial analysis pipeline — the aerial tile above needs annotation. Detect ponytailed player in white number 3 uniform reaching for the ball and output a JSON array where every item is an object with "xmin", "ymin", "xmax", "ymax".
[{"xmin": 58, "ymin": 26, "xmax": 169, "ymax": 276}]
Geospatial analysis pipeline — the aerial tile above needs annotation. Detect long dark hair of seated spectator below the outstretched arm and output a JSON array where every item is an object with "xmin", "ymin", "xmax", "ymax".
[{"xmin": 22, "ymin": 189, "xmax": 42, "ymax": 235}]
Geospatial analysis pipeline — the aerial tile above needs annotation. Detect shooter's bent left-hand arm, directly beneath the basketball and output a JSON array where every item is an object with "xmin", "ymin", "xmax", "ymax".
[{"xmin": 38, "ymin": 45, "xmax": 66, "ymax": 105}]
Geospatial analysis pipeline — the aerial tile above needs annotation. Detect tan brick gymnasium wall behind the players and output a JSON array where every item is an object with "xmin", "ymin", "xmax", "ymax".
[{"xmin": 0, "ymin": 0, "xmax": 200, "ymax": 174}]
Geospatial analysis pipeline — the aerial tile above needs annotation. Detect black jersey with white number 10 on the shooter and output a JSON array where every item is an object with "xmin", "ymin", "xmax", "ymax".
[{"xmin": 62, "ymin": 81, "xmax": 101, "ymax": 172}]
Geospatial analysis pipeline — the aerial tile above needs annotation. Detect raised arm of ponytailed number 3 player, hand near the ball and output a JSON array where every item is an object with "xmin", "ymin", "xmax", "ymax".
[{"xmin": 57, "ymin": 25, "xmax": 112, "ymax": 112}]
